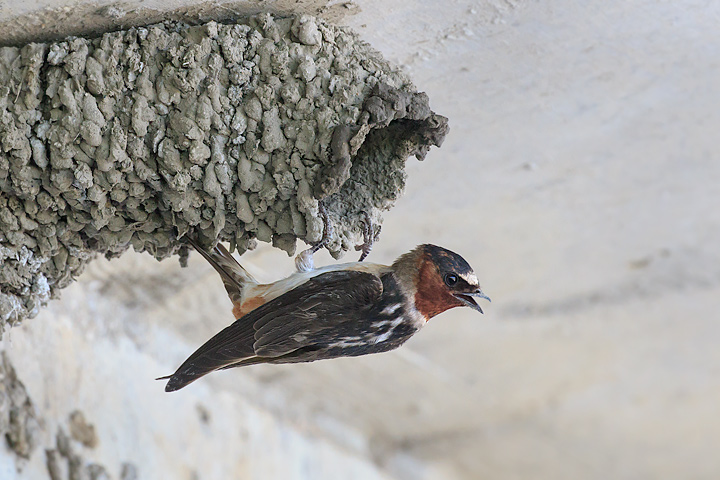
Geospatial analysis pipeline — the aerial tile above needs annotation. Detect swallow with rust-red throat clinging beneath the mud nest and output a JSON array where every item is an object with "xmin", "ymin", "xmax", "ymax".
[{"xmin": 158, "ymin": 235, "xmax": 490, "ymax": 392}]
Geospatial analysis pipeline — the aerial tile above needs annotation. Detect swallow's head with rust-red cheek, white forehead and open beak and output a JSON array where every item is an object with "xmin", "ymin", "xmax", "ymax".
[{"xmin": 396, "ymin": 244, "xmax": 490, "ymax": 319}]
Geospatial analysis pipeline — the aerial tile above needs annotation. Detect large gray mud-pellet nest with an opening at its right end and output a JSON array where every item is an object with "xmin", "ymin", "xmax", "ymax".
[{"xmin": 0, "ymin": 14, "xmax": 447, "ymax": 331}]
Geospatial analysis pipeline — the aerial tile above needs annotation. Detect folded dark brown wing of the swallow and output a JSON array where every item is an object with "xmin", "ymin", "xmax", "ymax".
[{"xmin": 165, "ymin": 270, "xmax": 383, "ymax": 392}]
